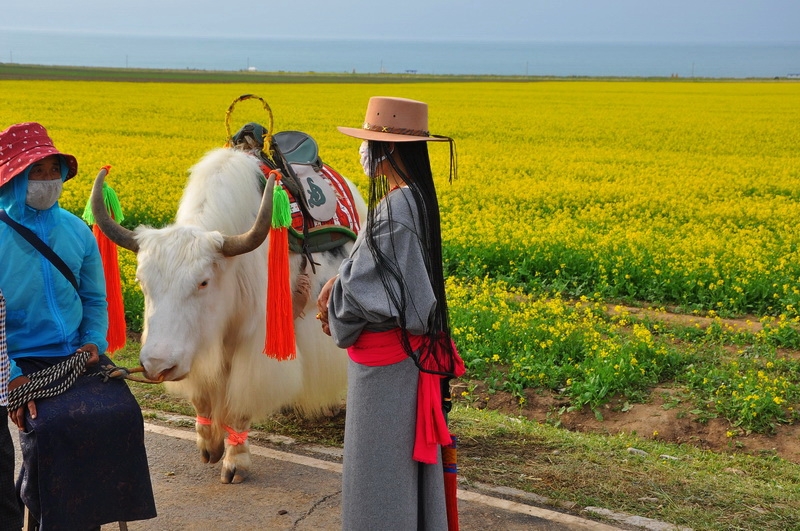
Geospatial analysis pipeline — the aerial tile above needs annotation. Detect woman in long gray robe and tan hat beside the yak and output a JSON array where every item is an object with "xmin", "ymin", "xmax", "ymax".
[{"xmin": 317, "ymin": 97, "xmax": 464, "ymax": 531}]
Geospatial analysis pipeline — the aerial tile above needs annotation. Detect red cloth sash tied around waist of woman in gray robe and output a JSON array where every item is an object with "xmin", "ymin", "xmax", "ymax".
[{"xmin": 347, "ymin": 328, "xmax": 464, "ymax": 464}]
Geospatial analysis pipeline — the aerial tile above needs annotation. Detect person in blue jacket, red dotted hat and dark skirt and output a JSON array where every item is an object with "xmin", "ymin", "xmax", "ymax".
[{"xmin": 0, "ymin": 122, "xmax": 155, "ymax": 531}]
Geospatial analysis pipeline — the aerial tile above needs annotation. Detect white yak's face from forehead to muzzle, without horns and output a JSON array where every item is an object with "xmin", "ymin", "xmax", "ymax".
[{"xmin": 136, "ymin": 226, "xmax": 234, "ymax": 380}]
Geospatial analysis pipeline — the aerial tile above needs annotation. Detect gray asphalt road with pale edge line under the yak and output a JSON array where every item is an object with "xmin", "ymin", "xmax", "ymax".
[{"xmin": 9, "ymin": 422, "xmax": 628, "ymax": 531}]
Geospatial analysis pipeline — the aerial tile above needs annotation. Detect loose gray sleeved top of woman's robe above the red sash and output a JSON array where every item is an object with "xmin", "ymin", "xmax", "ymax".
[{"xmin": 328, "ymin": 190, "xmax": 436, "ymax": 348}]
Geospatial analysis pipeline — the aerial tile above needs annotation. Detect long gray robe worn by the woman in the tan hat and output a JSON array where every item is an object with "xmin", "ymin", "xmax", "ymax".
[{"xmin": 328, "ymin": 188, "xmax": 447, "ymax": 531}]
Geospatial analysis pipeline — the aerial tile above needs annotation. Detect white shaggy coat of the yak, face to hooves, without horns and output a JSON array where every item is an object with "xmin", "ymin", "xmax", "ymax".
[{"xmin": 136, "ymin": 148, "xmax": 366, "ymax": 482}]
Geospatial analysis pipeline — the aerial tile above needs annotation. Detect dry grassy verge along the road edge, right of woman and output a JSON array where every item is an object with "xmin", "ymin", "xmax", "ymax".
[{"xmin": 450, "ymin": 406, "xmax": 800, "ymax": 531}]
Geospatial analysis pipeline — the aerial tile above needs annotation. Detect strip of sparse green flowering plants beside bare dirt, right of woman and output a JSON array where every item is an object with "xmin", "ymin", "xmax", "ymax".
[{"xmin": 448, "ymin": 279, "xmax": 800, "ymax": 433}]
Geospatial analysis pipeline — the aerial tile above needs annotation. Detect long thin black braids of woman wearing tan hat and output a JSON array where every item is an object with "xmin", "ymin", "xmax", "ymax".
[{"xmin": 365, "ymin": 139, "xmax": 456, "ymax": 378}]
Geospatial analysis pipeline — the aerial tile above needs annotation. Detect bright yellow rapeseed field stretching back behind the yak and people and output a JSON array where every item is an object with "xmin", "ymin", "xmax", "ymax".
[{"xmin": 0, "ymin": 80, "xmax": 800, "ymax": 428}]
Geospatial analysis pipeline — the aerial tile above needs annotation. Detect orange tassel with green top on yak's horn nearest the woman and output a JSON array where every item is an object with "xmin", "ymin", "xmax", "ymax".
[{"xmin": 264, "ymin": 171, "xmax": 297, "ymax": 360}]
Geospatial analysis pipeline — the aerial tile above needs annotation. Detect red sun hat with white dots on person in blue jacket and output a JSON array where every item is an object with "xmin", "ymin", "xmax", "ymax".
[{"xmin": 0, "ymin": 122, "xmax": 78, "ymax": 186}]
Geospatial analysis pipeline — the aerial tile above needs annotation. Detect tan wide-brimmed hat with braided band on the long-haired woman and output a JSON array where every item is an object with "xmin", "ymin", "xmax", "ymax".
[{"xmin": 337, "ymin": 96, "xmax": 451, "ymax": 142}]
